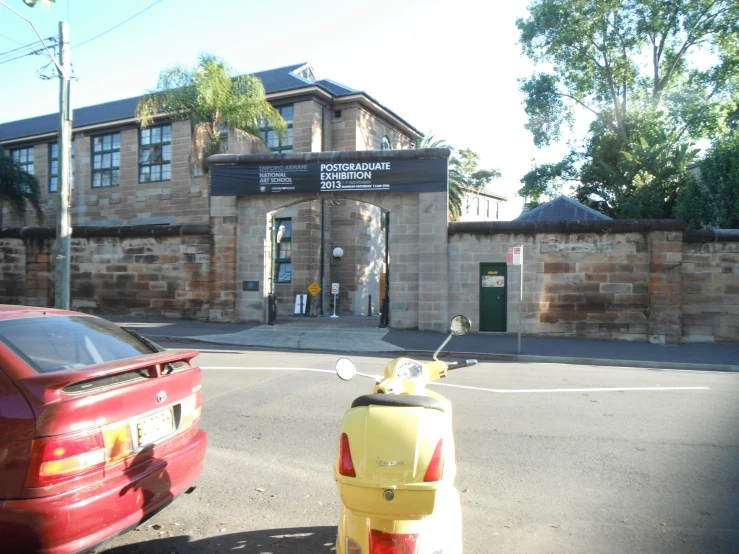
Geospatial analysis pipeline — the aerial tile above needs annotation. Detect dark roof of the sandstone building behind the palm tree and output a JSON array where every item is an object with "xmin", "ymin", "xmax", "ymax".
[{"xmin": 0, "ymin": 63, "xmax": 423, "ymax": 141}]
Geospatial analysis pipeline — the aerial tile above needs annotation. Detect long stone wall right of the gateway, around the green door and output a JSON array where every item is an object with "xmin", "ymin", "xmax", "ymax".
[{"xmin": 448, "ymin": 220, "xmax": 739, "ymax": 343}]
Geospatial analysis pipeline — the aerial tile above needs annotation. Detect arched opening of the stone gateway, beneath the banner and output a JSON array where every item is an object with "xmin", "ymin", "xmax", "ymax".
[{"xmin": 265, "ymin": 195, "xmax": 389, "ymax": 323}]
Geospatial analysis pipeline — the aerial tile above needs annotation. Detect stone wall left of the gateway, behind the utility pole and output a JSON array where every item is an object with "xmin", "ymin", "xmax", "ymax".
[{"xmin": 0, "ymin": 226, "xmax": 213, "ymax": 319}]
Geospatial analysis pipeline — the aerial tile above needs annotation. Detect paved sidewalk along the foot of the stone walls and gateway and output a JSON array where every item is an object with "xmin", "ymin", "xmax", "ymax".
[{"xmin": 108, "ymin": 316, "xmax": 739, "ymax": 372}]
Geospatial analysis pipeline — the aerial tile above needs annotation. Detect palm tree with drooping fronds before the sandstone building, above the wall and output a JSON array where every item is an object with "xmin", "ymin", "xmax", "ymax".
[{"xmin": 136, "ymin": 54, "xmax": 287, "ymax": 172}]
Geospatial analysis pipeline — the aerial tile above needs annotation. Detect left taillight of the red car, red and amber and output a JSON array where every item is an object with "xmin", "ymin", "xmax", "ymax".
[{"xmin": 26, "ymin": 429, "xmax": 105, "ymax": 487}]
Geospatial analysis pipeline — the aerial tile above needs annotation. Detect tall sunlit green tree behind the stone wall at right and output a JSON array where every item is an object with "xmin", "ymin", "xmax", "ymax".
[{"xmin": 517, "ymin": 0, "xmax": 739, "ymax": 217}]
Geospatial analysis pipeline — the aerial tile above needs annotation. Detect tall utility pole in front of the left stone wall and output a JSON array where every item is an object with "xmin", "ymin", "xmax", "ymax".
[{"xmin": 54, "ymin": 21, "xmax": 72, "ymax": 310}]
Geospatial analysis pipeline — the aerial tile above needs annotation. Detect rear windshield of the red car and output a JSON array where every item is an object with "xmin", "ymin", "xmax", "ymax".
[{"xmin": 0, "ymin": 315, "xmax": 156, "ymax": 373}]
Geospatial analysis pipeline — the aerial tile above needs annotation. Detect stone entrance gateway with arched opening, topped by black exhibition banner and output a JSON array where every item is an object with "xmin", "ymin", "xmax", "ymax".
[{"xmin": 208, "ymin": 148, "xmax": 450, "ymax": 331}]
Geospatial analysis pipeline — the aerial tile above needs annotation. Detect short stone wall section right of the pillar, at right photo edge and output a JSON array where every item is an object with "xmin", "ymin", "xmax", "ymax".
[{"xmin": 682, "ymin": 230, "xmax": 739, "ymax": 342}]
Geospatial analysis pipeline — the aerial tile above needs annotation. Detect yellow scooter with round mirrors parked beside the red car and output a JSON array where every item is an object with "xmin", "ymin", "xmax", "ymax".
[{"xmin": 334, "ymin": 315, "xmax": 477, "ymax": 554}]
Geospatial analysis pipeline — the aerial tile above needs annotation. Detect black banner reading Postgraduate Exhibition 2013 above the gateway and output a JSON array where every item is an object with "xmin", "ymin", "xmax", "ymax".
[{"xmin": 210, "ymin": 158, "xmax": 447, "ymax": 196}]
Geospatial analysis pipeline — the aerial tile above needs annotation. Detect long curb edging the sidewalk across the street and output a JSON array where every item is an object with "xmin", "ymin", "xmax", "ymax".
[{"xmin": 152, "ymin": 335, "xmax": 739, "ymax": 373}]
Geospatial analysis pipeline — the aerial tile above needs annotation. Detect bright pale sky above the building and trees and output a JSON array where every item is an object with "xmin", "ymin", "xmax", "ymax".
[{"xmin": 0, "ymin": 0, "xmax": 566, "ymax": 219}]
